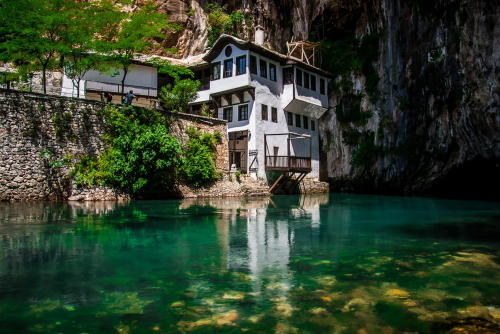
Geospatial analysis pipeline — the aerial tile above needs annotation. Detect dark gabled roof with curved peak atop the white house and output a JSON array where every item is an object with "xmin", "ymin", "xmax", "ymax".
[{"xmin": 203, "ymin": 34, "xmax": 331, "ymax": 77}]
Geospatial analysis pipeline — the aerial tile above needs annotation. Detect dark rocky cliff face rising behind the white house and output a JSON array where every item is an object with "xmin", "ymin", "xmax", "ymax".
[{"xmin": 157, "ymin": 0, "xmax": 500, "ymax": 198}]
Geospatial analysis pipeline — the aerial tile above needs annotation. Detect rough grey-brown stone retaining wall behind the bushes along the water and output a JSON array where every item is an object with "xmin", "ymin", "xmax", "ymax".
[{"xmin": 0, "ymin": 89, "xmax": 229, "ymax": 201}]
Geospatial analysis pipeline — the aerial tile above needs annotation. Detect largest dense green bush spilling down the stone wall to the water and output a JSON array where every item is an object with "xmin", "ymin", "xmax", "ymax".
[{"xmin": 72, "ymin": 106, "xmax": 182, "ymax": 195}]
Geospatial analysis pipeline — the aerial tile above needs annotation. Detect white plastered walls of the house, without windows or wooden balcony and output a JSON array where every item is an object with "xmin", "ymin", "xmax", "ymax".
[{"xmin": 194, "ymin": 36, "xmax": 328, "ymax": 179}]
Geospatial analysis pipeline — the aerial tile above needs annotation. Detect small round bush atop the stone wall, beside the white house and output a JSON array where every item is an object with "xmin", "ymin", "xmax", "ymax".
[{"xmin": 160, "ymin": 79, "xmax": 200, "ymax": 112}]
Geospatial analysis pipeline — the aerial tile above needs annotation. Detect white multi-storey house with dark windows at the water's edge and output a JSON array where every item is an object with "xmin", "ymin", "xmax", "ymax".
[{"xmin": 192, "ymin": 32, "xmax": 329, "ymax": 180}]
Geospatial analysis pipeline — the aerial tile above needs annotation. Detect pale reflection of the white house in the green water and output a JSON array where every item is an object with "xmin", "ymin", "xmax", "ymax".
[{"xmin": 179, "ymin": 194, "xmax": 329, "ymax": 291}]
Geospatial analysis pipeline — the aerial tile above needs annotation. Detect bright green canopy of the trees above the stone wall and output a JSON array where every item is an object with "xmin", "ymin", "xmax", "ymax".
[{"xmin": 0, "ymin": 0, "xmax": 178, "ymax": 93}]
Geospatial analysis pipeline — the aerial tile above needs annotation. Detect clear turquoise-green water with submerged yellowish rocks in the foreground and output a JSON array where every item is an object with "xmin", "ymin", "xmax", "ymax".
[{"xmin": 0, "ymin": 195, "xmax": 500, "ymax": 334}]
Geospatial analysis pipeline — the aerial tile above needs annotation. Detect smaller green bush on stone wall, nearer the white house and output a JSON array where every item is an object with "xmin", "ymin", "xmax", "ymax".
[{"xmin": 182, "ymin": 127, "xmax": 221, "ymax": 187}]
